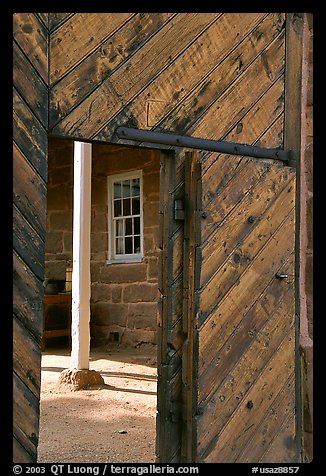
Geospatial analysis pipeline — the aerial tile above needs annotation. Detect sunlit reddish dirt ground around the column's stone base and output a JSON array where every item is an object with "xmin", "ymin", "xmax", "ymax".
[{"xmin": 38, "ymin": 344, "xmax": 157, "ymax": 463}]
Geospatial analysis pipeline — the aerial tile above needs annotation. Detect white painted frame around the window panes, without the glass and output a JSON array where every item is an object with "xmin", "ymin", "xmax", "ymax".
[{"xmin": 106, "ymin": 170, "xmax": 144, "ymax": 264}]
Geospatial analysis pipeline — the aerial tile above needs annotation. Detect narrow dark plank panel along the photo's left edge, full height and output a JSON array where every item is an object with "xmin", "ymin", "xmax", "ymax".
[{"xmin": 13, "ymin": 13, "xmax": 49, "ymax": 463}]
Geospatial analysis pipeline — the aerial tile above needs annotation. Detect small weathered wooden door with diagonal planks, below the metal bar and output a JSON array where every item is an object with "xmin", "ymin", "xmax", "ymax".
[{"xmin": 182, "ymin": 153, "xmax": 299, "ymax": 463}]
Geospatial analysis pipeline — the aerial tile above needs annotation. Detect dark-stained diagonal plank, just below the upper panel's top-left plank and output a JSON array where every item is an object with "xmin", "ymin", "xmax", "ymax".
[{"xmin": 50, "ymin": 13, "xmax": 175, "ymax": 127}]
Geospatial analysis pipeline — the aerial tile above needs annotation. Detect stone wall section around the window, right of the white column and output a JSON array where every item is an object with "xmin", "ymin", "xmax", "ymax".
[{"xmin": 91, "ymin": 144, "xmax": 160, "ymax": 345}]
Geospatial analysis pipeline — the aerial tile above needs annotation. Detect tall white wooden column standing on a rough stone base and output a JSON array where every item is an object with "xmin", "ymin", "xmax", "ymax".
[{"xmin": 71, "ymin": 142, "xmax": 92, "ymax": 370}]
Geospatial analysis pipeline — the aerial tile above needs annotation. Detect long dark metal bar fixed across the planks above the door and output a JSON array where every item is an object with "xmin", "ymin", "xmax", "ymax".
[{"xmin": 116, "ymin": 126, "xmax": 293, "ymax": 162}]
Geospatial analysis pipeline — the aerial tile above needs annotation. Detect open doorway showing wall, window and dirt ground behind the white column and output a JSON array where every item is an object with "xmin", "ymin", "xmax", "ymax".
[{"xmin": 38, "ymin": 138, "xmax": 161, "ymax": 462}]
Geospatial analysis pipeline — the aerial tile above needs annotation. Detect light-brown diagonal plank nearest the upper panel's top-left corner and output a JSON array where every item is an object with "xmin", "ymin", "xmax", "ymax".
[{"xmin": 49, "ymin": 13, "xmax": 134, "ymax": 84}]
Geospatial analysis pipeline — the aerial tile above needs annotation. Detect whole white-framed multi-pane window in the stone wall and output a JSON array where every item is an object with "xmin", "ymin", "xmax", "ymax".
[{"xmin": 107, "ymin": 170, "xmax": 144, "ymax": 263}]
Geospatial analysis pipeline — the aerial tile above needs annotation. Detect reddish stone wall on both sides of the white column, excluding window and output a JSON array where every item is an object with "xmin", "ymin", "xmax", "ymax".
[{"xmin": 45, "ymin": 139, "xmax": 160, "ymax": 346}]
